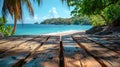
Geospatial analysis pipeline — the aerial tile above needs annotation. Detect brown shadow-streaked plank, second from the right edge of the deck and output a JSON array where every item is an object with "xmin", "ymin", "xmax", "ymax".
[{"xmin": 72, "ymin": 38, "xmax": 120, "ymax": 67}]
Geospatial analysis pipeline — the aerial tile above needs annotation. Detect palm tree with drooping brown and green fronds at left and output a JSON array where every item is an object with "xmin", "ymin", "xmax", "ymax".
[{"xmin": 2, "ymin": 0, "xmax": 41, "ymax": 34}]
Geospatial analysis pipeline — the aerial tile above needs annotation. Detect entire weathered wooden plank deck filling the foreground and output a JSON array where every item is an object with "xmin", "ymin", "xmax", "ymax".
[{"xmin": 0, "ymin": 33, "xmax": 120, "ymax": 67}]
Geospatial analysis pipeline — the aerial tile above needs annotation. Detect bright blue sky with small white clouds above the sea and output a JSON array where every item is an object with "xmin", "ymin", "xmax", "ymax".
[{"xmin": 0, "ymin": 0, "xmax": 73, "ymax": 24}]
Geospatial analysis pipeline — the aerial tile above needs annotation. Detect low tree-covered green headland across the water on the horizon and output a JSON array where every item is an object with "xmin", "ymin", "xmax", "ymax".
[{"xmin": 41, "ymin": 17, "xmax": 91, "ymax": 25}]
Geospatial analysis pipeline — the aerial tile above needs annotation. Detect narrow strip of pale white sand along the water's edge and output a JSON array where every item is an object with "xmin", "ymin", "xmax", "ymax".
[{"xmin": 43, "ymin": 30, "xmax": 85, "ymax": 36}]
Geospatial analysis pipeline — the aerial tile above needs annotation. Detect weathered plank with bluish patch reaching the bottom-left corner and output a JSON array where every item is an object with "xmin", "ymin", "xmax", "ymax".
[{"xmin": 0, "ymin": 38, "xmax": 49, "ymax": 67}]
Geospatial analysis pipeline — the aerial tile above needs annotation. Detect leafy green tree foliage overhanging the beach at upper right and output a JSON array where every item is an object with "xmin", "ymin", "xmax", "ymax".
[{"xmin": 63, "ymin": 0, "xmax": 120, "ymax": 26}]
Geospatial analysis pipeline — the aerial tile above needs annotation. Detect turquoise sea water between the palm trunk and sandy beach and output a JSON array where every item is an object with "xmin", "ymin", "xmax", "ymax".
[{"xmin": 9, "ymin": 24, "xmax": 92, "ymax": 35}]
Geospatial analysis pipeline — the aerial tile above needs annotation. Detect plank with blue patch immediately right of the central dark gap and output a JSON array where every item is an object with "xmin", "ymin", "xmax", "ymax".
[{"xmin": 63, "ymin": 37, "xmax": 101, "ymax": 67}]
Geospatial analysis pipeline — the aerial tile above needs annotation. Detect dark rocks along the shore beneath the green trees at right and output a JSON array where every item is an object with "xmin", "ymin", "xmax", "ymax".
[{"xmin": 86, "ymin": 26, "xmax": 120, "ymax": 35}]
